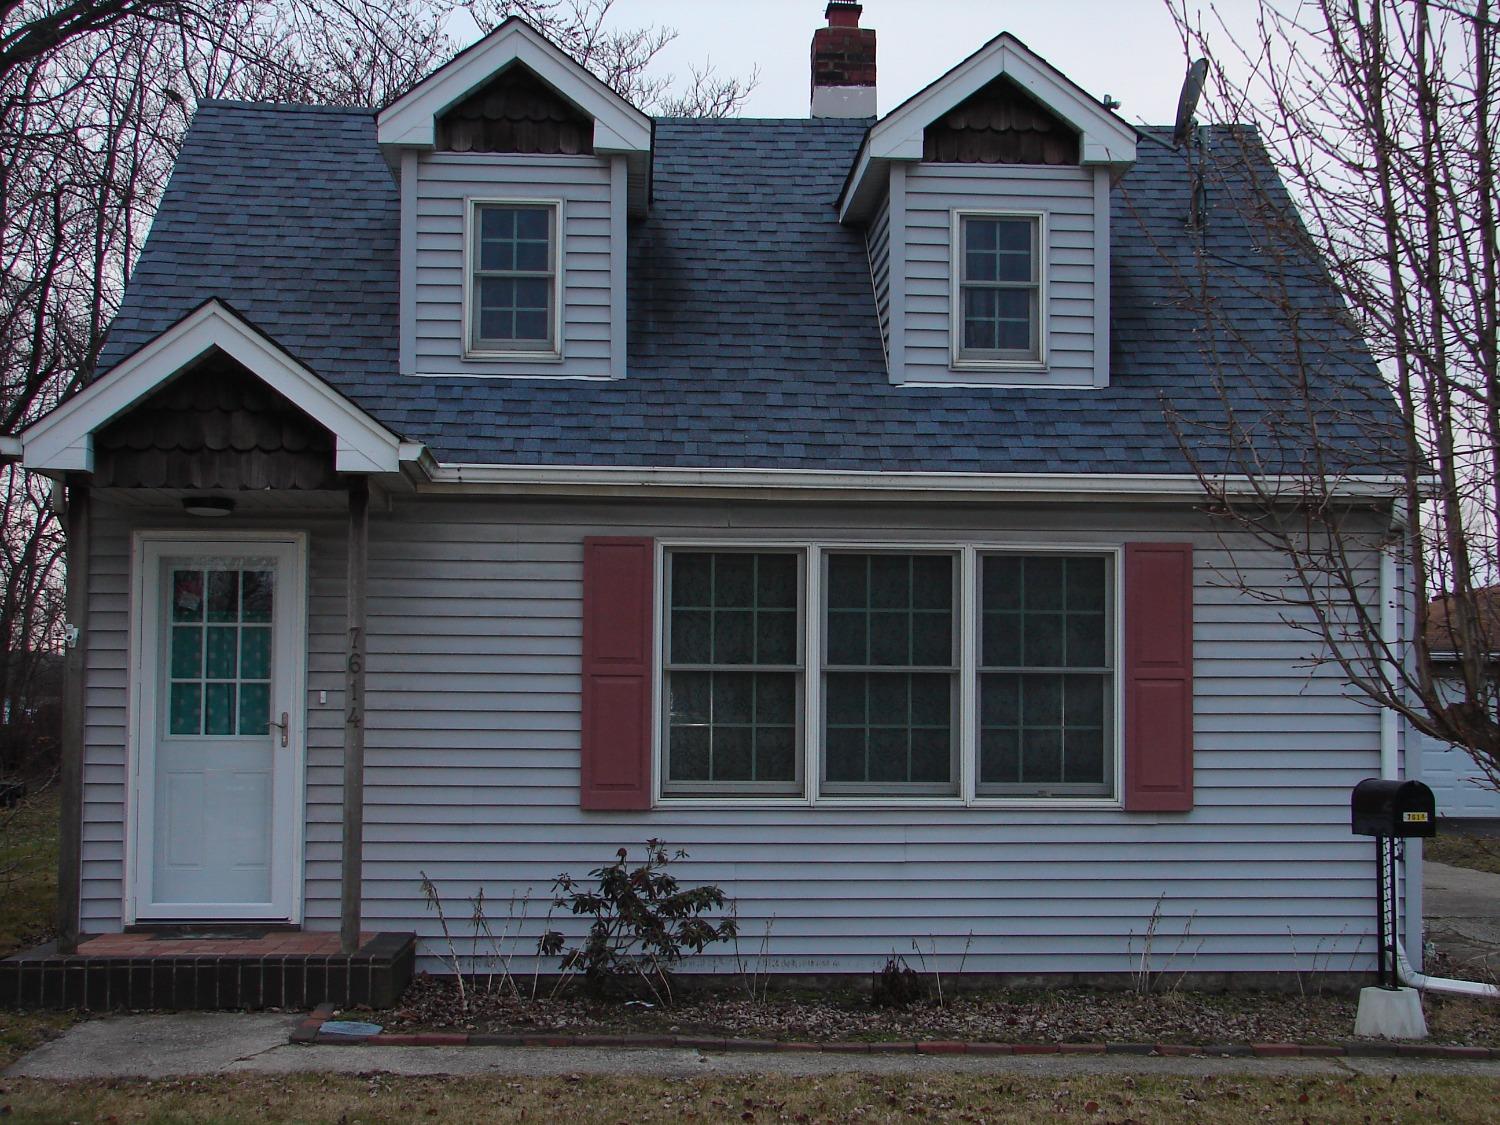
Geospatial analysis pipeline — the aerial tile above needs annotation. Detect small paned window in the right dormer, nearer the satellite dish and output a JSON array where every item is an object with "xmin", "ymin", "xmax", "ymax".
[{"xmin": 953, "ymin": 213, "xmax": 1046, "ymax": 365}]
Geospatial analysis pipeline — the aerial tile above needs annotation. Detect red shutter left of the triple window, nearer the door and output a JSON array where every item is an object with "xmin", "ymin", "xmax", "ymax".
[{"xmin": 579, "ymin": 539, "xmax": 656, "ymax": 809}]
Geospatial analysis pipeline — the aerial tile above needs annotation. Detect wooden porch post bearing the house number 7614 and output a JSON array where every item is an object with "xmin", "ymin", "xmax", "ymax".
[{"xmin": 339, "ymin": 477, "xmax": 371, "ymax": 954}]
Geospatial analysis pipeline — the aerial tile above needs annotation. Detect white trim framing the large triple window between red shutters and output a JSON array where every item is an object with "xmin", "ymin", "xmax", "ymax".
[{"xmin": 651, "ymin": 539, "xmax": 1125, "ymax": 812}]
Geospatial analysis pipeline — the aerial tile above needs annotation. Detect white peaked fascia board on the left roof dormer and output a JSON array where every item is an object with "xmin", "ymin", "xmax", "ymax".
[{"xmin": 375, "ymin": 23, "xmax": 651, "ymax": 152}]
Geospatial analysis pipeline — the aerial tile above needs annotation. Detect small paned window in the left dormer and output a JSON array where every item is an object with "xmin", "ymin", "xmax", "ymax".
[{"xmin": 468, "ymin": 200, "xmax": 558, "ymax": 356}]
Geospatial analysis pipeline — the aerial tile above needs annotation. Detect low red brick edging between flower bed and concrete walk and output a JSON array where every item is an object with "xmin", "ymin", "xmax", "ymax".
[{"xmin": 291, "ymin": 1020, "xmax": 1500, "ymax": 1059}]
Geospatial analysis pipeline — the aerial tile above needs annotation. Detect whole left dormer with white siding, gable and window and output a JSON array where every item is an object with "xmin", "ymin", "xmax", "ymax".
[{"xmin": 377, "ymin": 18, "xmax": 653, "ymax": 380}]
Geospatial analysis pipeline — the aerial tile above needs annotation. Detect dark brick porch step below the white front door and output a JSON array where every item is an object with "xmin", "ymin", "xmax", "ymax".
[{"xmin": 0, "ymin": 933, "xmax": 417, "ymax": 1011}]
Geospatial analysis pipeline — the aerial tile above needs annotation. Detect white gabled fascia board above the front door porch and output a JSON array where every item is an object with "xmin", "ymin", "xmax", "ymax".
[{"xmin": 21, "ymin": 302, "xmax": 401, "ymax": 473}]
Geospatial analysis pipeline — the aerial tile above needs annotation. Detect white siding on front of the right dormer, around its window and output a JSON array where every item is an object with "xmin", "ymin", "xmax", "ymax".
[{"xmin": 891, "ymin": 164, "xmax": 1109, "ymax": 387}]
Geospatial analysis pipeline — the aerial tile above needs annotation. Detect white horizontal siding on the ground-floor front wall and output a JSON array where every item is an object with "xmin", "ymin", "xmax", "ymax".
[{"xmin": 84, "ymin": 498, "xmax": 1379, "ymax": 974}]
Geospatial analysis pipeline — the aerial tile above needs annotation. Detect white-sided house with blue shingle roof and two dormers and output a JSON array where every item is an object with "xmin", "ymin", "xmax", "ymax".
[{"xmin": 0, "ymin": 0, "xmax": 1421, "ymax": 1002}]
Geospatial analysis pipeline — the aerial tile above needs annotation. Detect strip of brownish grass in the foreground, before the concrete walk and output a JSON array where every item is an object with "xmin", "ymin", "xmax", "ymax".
[{"xmin": 0, "ymin": 1074, "xmax": 1497, "ymax": 1125}]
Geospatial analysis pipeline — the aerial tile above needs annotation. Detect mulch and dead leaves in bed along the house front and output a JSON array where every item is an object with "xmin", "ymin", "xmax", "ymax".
[{"xmin": 378, "ymin": 975, "xmax": 1500, "ymax": 1046}]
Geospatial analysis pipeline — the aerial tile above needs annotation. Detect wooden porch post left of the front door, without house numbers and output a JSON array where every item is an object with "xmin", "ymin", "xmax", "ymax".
[{"xmin": 57, "ymin": 474, "xmax": 89, "ymax": 953}]
